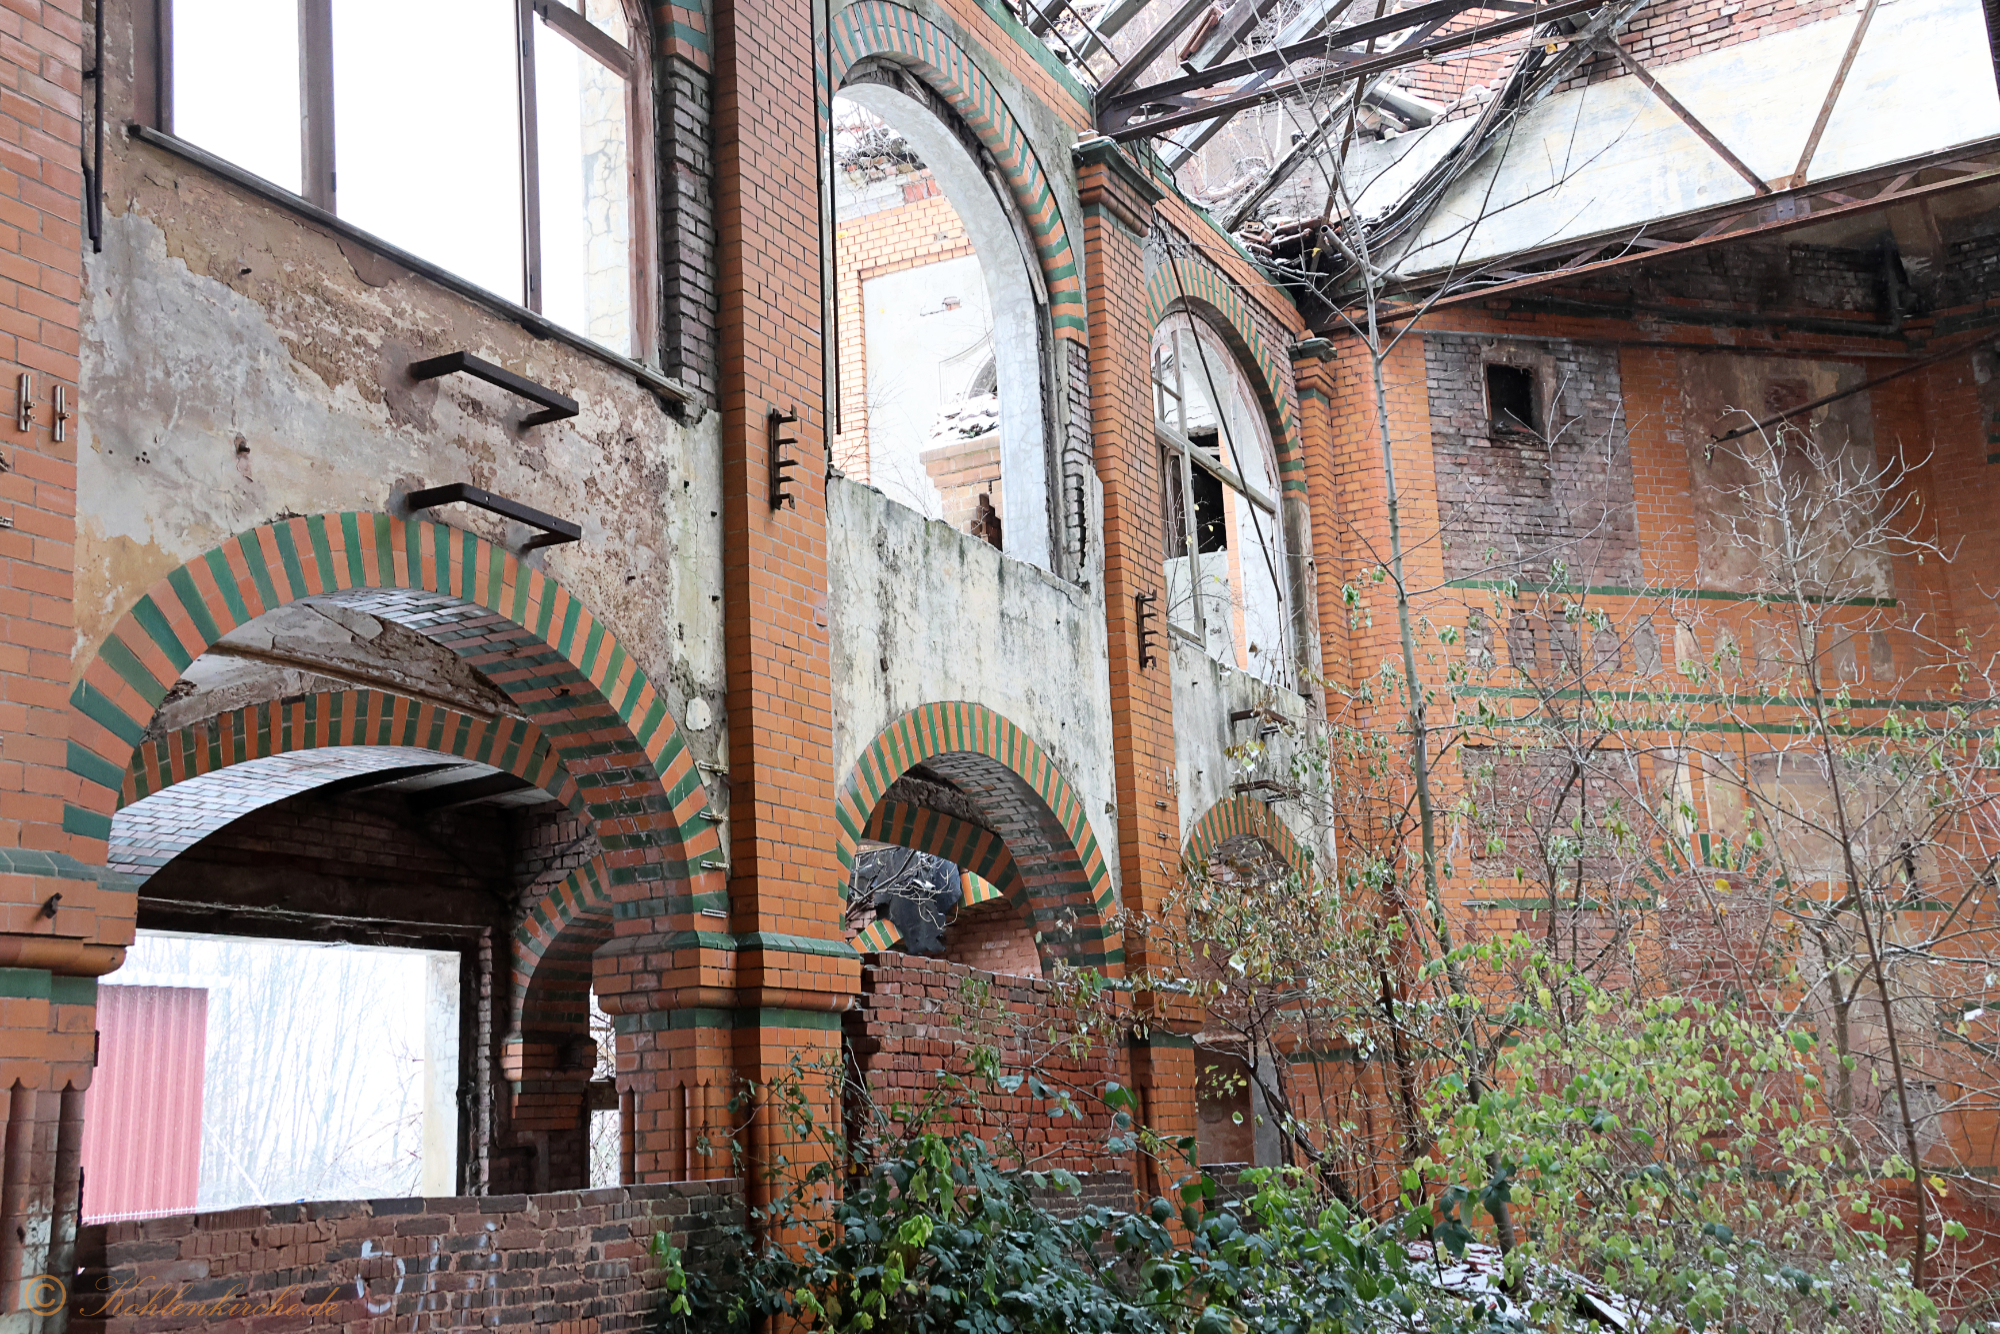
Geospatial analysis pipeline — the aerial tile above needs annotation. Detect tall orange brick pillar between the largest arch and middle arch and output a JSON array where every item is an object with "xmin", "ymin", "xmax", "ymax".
[{"xmin": 704, "ymin": 0, "xmax": 860, "ymax": 1198}]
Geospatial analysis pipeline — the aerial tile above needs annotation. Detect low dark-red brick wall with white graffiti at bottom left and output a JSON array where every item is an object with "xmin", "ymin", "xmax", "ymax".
[{"xmin": 70, "ymin": 1182, "xmax": 742, "ymax": 1334}]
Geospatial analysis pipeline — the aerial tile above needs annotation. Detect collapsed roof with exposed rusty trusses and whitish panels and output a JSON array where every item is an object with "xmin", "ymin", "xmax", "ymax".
[{"xmin": 1014, "ymin": 0, "xmax": 2000, "ymax": 322}]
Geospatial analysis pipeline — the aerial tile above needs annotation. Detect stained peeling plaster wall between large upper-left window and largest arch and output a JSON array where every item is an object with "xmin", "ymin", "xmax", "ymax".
[{"xmin": 74, "ymin": 146, "xmax": 724, "ymax": 760}]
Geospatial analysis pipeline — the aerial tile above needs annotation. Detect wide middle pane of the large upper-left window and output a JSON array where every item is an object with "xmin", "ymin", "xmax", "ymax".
[{"xmin": 334, "ymin": 0, "xmax": 524, "ymax": 300}]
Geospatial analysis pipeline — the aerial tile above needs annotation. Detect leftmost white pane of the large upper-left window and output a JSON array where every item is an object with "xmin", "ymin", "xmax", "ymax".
[{"xmin": 174, "ymin": 0, "xmax": 304, "ymax": 190}]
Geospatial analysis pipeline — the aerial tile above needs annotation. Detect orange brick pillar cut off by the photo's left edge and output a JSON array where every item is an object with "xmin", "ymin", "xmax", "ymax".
[{"xmin": 0, "ymin": 0, "xmax": 121, "ymax": 1332}]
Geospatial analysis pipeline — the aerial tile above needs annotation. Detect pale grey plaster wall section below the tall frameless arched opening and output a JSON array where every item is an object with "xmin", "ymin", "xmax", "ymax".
[{"xmin": 826, "ymin": 478, "xmax": 1118, "ymax": 880}]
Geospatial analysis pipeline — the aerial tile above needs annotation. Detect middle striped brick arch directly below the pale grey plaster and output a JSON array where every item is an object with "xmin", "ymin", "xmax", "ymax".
[{"xmin": 834, "ymin": 702, "xmax": 1124, "ymax": 964}]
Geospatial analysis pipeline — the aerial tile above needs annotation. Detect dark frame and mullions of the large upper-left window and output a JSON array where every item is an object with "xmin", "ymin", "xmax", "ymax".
[{"xmin": 156, "ymin": 0, "xmax": 658, "ymax": 370}]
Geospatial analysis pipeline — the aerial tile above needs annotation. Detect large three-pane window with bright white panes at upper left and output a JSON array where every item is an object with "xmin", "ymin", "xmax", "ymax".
[{"xmin": 162, "ymin": 0, "xmax": 644, "ymax": 356}]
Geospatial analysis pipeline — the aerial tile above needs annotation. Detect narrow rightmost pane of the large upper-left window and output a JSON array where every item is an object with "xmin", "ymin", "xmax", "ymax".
[{"xmin": 534, "ymin": 18, "xmax": 632, "ymax": 356}]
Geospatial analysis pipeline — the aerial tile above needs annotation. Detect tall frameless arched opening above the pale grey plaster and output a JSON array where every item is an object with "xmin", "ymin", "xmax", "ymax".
[{"xmin": 832, "ymin": 82, "xmax": 1052, "ymax": 568}]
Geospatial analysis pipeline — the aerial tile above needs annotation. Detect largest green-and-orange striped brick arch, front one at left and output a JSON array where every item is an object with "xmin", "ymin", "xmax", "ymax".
[{"xmin": 64, "ymin": 512, "xmax": 722, "ymax": 936}]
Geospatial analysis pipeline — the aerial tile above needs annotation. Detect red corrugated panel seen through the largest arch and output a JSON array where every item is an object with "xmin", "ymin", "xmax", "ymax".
[{"xmin": 84, "ymin": 986, "xmax": 208, "ymax": 1222}]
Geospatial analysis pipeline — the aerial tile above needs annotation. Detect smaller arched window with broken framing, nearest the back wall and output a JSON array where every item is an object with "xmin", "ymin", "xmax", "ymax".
[{"xmin": 1152, "ymin": 312, "xmax": 1296, "ymax": 686}]
